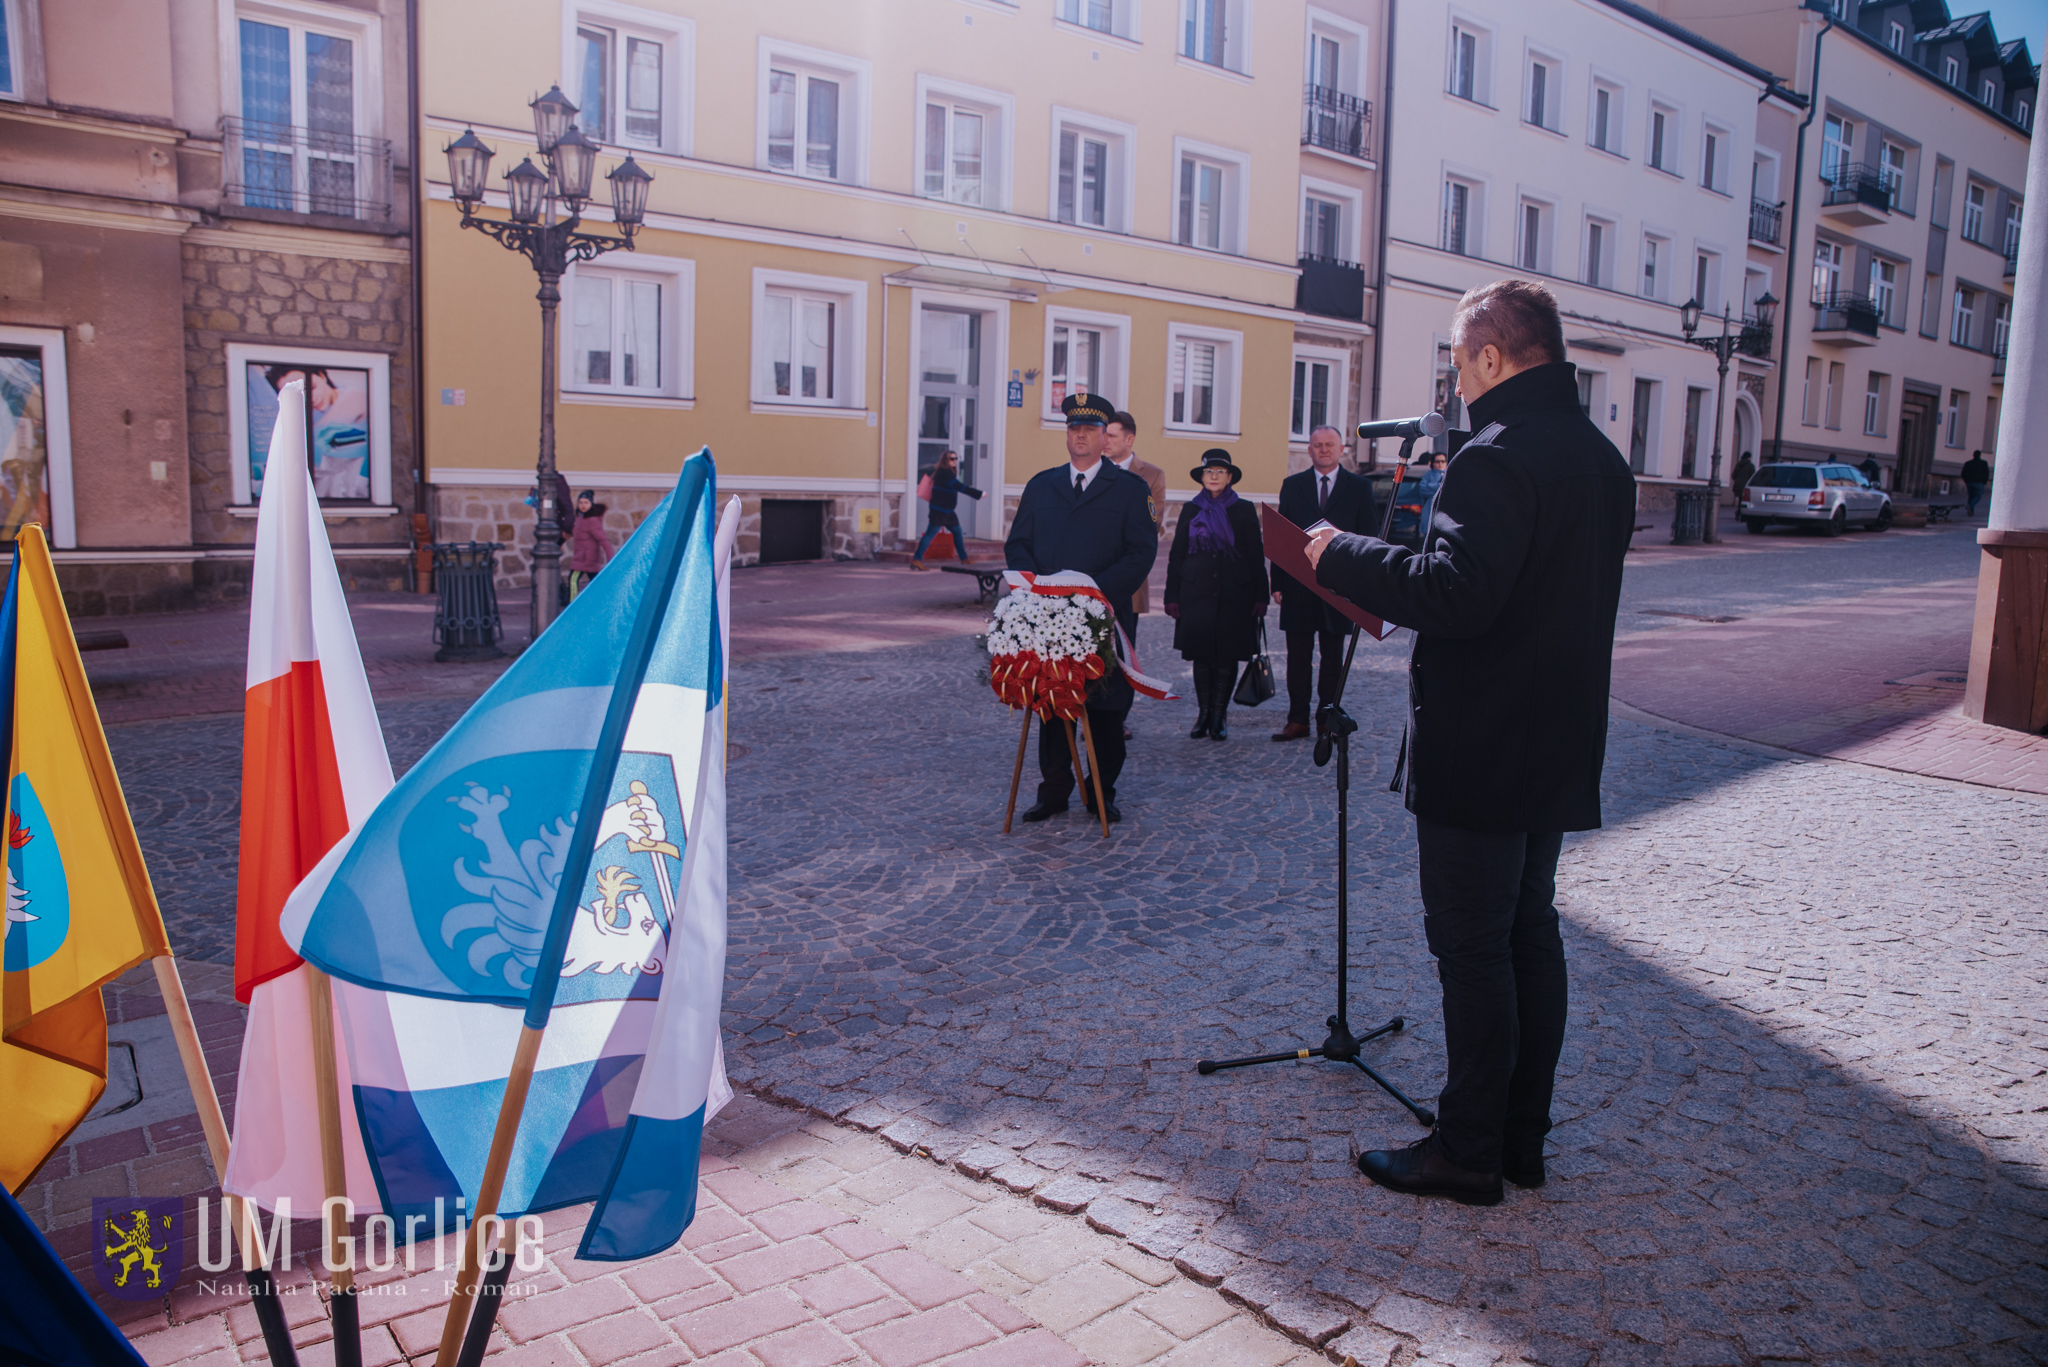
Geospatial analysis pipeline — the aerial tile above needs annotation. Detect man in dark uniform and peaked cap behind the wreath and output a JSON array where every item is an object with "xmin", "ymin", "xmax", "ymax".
[{"xmin": 1004, "ymin": 393, "xmax": 1159, "ymax": 822}]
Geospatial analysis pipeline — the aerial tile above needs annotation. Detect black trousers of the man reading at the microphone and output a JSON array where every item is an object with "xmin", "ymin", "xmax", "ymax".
[{"xmin": 1415, "ymin": 818, "xmax": 1567, "ymax": 1172}]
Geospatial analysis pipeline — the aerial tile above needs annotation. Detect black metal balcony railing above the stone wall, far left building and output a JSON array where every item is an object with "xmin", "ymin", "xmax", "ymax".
[{"xmin": 221, "ymin": 119, "xmax": 391, "ymax": 219}]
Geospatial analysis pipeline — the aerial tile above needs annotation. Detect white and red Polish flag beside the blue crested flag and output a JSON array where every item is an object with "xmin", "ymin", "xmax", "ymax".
[{"xmin": 221, "ymin": 379, "xmax": 391, "ymax": 1215}]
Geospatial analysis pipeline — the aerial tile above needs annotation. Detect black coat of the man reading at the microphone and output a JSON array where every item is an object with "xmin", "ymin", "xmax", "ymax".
[{"xmin": 1315, "ymin": 363, "xmax": 1636, "ymax": 832}]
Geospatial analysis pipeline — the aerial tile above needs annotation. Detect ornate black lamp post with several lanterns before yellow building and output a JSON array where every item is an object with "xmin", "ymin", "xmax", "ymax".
[{"xmin": 446, "ymin": 86, "xmax": 653, "ymax": 639}]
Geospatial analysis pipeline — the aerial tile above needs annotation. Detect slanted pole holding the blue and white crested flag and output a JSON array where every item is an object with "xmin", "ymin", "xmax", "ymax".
[{"xmin": 434, "ymin": 463, "xmax": 709, "ymax": 1367}]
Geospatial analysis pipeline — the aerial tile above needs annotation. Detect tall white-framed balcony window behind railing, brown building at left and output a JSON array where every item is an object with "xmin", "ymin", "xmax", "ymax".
[{"xmin": 234, "ymin": 0, "xmax": 389, "ymax": 217}]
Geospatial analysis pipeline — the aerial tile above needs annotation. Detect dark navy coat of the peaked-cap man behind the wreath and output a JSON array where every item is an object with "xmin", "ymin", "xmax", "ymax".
[{"xmin": 1004, "ymin": 461, "xmax": 1159, "ymax": 707}]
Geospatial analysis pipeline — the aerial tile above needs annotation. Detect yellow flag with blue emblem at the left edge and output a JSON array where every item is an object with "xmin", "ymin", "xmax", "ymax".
[{"xmin": 0, "ymin": 523, "xmax": 170, "ymax": 1191}]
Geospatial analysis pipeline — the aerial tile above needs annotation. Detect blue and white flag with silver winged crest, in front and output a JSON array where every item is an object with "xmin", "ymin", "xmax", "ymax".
[{"xmin": 281, "ymin": 451, "xmax": 737, "ymax": 1256}]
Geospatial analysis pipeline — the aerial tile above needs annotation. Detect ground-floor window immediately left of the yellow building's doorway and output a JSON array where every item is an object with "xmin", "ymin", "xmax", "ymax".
[{"xmin": 754, "ymin": 268, "xmax": 868, "ymax": 408}]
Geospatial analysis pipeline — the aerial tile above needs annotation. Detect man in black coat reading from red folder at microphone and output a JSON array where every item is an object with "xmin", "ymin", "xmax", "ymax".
[{"xmin": 1309, "ymin": 281, "xmax": 1634, "ymax": 1205}]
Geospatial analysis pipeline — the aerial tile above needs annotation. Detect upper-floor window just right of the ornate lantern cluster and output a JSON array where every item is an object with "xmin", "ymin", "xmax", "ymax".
[{"xmin": 567, "ymin": 0, "xmax": 696, "ymax": 156}]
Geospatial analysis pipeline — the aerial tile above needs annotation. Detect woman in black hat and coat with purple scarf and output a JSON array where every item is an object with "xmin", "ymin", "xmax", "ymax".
[{"xmin": 1165, "ymin": 449, "xmax": 1268, "ymax": 740}]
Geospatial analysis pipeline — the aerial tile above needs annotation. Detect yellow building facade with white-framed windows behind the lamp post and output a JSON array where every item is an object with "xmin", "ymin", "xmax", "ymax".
[{"xmin": 420, "ymin": 0, "xmax": 1335, "ymax": 584}]
